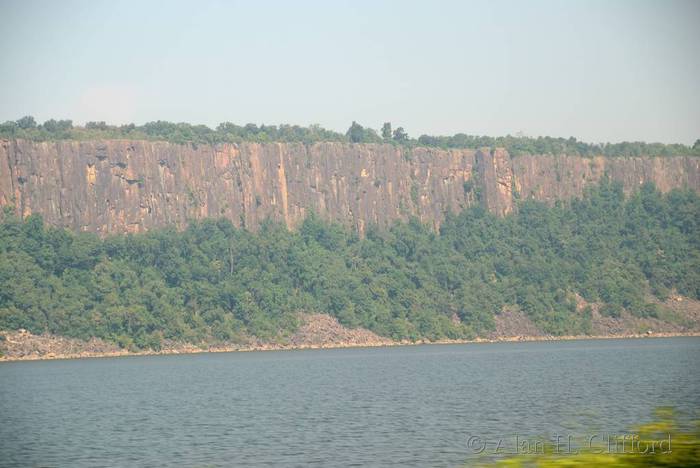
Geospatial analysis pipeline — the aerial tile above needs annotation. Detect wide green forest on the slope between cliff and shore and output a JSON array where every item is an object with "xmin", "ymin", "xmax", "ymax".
[{"xmin": 0, "ymin": 179, "xmax": 700, "ymax": 349}]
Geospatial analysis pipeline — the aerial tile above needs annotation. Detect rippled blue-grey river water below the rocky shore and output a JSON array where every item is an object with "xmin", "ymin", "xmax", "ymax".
[{"xmin": 0, "ymin": 338, "xmax": 700, "ymax": 467}]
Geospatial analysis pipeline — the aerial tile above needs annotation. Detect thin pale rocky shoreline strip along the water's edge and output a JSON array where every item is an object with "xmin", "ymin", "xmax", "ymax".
[{"xmin": 0, "ymin": 331, "xmax": 700, "ymax": 363}]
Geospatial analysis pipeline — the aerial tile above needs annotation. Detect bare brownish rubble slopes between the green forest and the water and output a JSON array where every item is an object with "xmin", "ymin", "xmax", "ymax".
[{"xmin": 0, "ymin": 296, "xmax": 700, "ymax": 362}]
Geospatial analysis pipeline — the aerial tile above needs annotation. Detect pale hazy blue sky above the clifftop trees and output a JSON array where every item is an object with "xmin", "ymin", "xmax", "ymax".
[{"xmin": 0, "ymin": 0, "xmax": 700, "ymax": 144}]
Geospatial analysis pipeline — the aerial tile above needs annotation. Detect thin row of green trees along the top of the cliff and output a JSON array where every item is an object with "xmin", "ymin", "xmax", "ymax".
[{"xmin": 0, "ymin": 116, "xmax": 700, "ymax": 157}]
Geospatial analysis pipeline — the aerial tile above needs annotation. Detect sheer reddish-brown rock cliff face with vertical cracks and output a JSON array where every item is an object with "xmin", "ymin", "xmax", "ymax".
[{"xmin": 0, "ymin": 140, "xmax": 700, "ymax": 234}]
